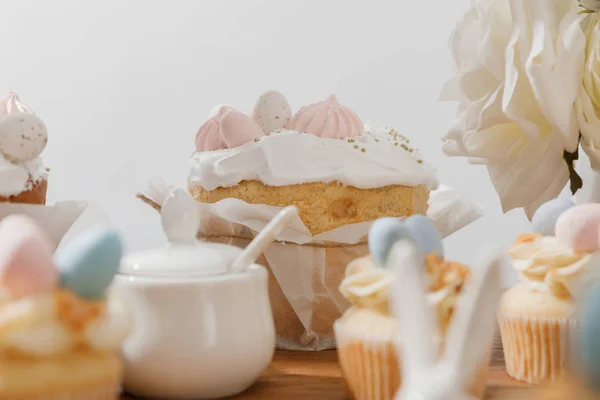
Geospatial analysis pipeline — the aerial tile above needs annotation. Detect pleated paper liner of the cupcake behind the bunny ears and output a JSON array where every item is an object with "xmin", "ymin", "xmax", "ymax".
[{"xmin": 334, "ymin": 323, "xmax": 491, "ymax": 400}]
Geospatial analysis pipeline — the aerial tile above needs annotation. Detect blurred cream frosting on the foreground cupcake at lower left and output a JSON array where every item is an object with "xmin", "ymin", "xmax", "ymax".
[{"xmin": 0, "ymin": 289, "xmax": 131, "ymax": 357}]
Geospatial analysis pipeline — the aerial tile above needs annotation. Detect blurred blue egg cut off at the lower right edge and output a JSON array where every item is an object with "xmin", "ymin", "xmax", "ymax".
[{"xmin": 575, "ymin": 286, "xmax": 600, "ymax": 390}]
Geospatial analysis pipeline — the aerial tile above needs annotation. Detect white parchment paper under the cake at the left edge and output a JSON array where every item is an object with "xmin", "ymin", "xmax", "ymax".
[{"xmin": 0, "ymin": 201, "xmax": 88, "ymax": 250}]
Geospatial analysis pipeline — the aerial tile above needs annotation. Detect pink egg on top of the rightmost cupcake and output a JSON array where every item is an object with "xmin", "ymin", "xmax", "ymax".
[{"xmin": 555, "ymin": 203, "xmax": 600, "ymax": 253}]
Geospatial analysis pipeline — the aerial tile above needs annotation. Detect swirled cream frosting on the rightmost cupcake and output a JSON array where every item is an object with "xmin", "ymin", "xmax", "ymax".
[{"xmin": 508, "ymin": 234, "xmax": 600, "ymax": 299}]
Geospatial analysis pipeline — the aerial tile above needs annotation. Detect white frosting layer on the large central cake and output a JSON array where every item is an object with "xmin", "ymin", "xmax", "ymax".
[{"xmin": 188, "ymin": 125, "xmax": 439, "ymax": 191}]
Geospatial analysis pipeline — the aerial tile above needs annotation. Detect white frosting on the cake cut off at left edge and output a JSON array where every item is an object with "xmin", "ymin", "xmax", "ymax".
[{"xmin": 0, "ymin": 154, "xmax": 48, "ymax": 197}]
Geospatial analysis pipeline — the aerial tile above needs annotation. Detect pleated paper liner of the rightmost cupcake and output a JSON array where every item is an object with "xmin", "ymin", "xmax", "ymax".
[{"xmin": 498, "ymin": 313, "xmax": 578, "ymax": 384}]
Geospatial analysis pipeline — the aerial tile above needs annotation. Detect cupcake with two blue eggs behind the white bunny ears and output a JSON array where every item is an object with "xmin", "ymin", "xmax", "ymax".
[{"xmin": 334, "ymin": 216, "xmax": 491, "ymax": 400}]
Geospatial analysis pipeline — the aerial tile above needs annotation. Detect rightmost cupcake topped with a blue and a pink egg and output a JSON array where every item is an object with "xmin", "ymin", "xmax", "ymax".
[{"xmin": 498, "ymin": 199, "xmax": 600, "ymax": 384}]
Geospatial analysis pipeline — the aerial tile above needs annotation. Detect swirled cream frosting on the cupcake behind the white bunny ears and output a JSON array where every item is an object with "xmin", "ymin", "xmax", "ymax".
[{"xmin": 340, "ymin": 254, "xmax": 469, "ymax": 332}]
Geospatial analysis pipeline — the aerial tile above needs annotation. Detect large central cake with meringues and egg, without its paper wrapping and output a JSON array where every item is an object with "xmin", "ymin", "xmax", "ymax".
[{"xmin": 189, "ymin": 91, "xmax": 438, "ymax": 235}]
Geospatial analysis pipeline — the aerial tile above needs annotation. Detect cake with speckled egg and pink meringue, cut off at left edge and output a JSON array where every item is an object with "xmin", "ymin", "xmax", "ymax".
[{"xmin": 0, "ymin": 92, "xmax": 48, "ymax": 204}]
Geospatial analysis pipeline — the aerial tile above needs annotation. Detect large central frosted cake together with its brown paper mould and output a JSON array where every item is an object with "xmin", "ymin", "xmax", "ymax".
[{"xmin": 188, "ymin": 91, "xmax": 438, "ymax": 350}]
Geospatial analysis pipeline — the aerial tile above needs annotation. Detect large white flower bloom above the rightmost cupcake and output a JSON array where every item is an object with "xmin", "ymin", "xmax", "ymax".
[{"xmin": 441, "ymin": 0, "xmax": 585, "ymax": 217}]
